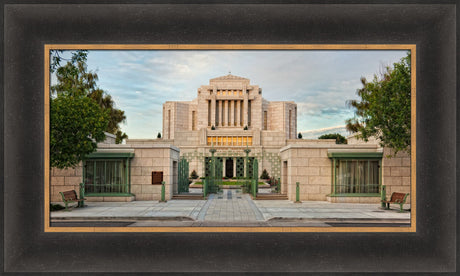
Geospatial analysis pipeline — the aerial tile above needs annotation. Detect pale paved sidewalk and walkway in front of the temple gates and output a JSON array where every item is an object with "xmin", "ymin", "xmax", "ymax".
[{"xmin": 51, "ymin": 189, "xmax": 410, "ymax": 226}]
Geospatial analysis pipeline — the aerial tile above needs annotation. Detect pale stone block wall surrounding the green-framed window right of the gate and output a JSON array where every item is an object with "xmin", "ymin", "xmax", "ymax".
[{"xmin": 280, "ymin": 140, "xmax": 411, "ymax": 203}]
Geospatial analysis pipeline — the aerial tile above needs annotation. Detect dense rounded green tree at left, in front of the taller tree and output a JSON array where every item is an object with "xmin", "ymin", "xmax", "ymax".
[{"xmin": 50, "ymin": 94, "xmax": 109, "ymax": 169}]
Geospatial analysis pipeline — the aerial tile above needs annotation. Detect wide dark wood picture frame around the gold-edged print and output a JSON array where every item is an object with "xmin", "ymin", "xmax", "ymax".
[{"xmin": 0, "ymin": 1, "xmax": 459, "ymax": 273}]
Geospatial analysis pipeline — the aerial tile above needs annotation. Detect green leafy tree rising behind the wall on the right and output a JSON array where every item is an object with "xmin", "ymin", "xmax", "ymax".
[{"xmin": 346, "ymin": 52, "xmax": 411, "ymax": 154}]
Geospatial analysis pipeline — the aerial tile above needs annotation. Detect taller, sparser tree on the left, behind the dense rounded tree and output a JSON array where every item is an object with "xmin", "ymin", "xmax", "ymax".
[{"xmin": 51, "ymin": 54, "xmax": 128, "ymax": 144}]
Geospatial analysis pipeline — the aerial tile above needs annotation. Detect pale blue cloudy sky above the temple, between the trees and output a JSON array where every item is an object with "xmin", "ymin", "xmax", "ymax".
[{"xmin": 53, "ymin": 50, "xmax": 406, "ymax": 139}]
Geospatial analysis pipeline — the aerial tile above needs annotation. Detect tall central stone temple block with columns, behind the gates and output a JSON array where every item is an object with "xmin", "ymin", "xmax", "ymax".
[{"xmin": 163, "ymin": 74, "xmax": 297, "ymax": 183}]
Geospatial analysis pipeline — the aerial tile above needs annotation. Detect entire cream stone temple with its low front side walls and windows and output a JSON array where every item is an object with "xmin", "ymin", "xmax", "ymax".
[{"xmin": 50, "ymin": 74, "xmax": 411, "ymax": 203}]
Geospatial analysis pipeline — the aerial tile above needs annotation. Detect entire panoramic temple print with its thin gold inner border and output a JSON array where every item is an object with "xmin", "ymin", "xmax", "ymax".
[{"xmin": 45, "ymin": 45, "xmax": 415, "ymax": 232}]
